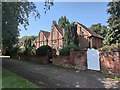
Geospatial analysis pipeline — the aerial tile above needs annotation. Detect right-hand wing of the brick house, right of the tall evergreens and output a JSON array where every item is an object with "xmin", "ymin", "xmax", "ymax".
[{"xmin": 75, "ymin": 22, "xmax": 103, "ymax": 48}]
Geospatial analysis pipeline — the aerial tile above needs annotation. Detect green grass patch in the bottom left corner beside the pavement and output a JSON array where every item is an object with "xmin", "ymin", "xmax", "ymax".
[{"xmin": 2, "ymin": 69, "xmax": 40, "ymax": 88}]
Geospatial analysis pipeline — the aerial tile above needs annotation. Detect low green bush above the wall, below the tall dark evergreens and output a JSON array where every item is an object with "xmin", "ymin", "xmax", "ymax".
[{"xmin": 60, "ymin": 45, "xmax": 80, "ymax": 56}]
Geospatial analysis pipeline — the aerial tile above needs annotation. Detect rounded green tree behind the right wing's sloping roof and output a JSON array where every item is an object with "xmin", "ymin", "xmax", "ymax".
[{"xmin": 90, "ymin": 23, "xmax": 108, "ymax": 38}]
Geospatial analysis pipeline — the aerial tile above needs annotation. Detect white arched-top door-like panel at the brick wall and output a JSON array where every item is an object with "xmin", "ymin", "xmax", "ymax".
[{"xmin": 87, "ymin": 49, "xmax": 100, "ymax": 71}]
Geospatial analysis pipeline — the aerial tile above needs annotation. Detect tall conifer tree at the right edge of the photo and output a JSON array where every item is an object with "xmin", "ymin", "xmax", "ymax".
[{"xmin": 105, "ymin": 1, "xmax": 120, "ymax": 45}]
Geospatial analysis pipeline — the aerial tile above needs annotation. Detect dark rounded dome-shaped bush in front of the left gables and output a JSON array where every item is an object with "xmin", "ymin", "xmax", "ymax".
[{"xmin": 36, "ymin": 45, "xmax": 52, "ymax": 56}]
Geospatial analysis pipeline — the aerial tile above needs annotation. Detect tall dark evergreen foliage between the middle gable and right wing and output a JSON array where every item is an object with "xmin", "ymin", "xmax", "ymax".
[{"xmin": 58, "ymin": 16, "xmax": 78, "ymax": 46}]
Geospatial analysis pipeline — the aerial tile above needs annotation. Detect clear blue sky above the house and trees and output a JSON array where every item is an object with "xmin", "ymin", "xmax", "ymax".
[{"xmin": 20, "ymin": 2, "xmax": 109, "ymax": 37}]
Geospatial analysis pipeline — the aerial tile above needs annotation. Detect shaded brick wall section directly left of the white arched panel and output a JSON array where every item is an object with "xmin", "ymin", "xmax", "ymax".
[{"xmin": 52, "ymin": 51, "xmax": 87, "ymax": 70}]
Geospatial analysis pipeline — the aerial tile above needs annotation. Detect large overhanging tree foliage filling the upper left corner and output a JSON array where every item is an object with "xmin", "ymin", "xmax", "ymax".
[{"xmin": 2, "ymin": 2, "xmax": 40, "ymax": 47}]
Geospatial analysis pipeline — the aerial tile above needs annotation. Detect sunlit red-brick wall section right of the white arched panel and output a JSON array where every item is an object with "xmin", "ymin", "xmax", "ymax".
[{"xmin": 100, "ymin": 51, "xmax": 120, "ymax": 75}]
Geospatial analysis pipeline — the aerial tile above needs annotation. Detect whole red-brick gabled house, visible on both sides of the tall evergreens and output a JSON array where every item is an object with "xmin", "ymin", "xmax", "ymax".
[{"xmin": 35, "ymin": 21, "xmax": 103, "ymax": 50}]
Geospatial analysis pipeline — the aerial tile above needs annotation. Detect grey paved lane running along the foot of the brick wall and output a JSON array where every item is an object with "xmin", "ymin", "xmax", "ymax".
[{"xmin": 2, "ymin": 59, "xmax": 120, "ymax": 89}]
